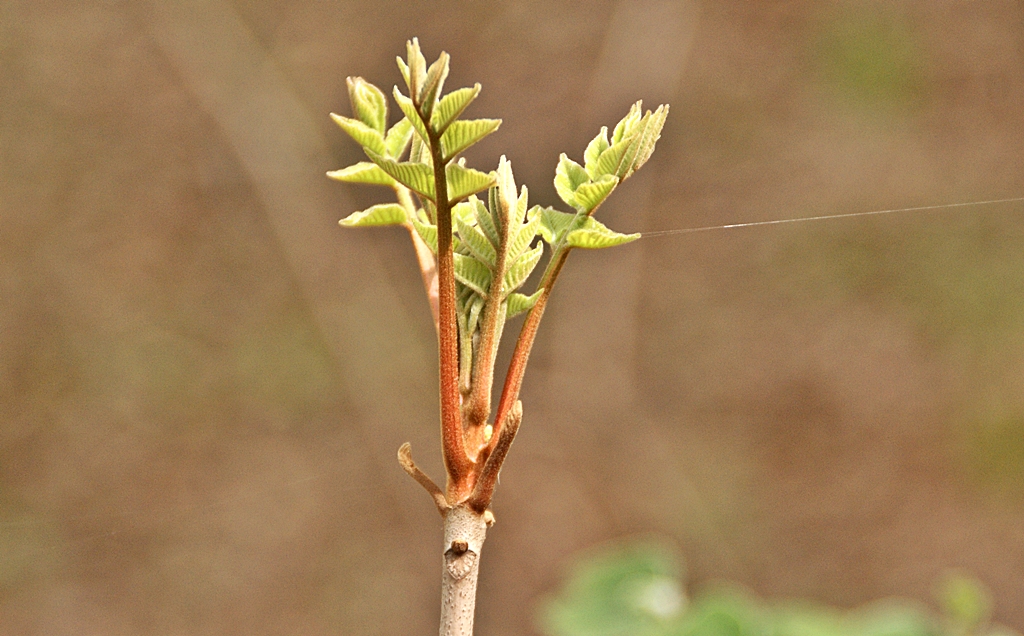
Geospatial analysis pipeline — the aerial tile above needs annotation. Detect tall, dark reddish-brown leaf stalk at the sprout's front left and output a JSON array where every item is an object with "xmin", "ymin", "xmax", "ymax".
[{"xmin": 424, "ymin": 126, "xmax": 472, "ymax": 491}]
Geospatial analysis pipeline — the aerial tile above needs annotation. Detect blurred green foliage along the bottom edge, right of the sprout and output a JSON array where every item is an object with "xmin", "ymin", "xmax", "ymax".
[{"xmin": 538, "ymin": 541, "xmax": 1014, "ymax": 636}]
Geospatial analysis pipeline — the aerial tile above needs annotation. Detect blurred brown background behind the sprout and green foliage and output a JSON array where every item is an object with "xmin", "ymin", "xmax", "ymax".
[{"xmin": 0, "ymin": 0, "xmax": 1024, "ymax": 635}]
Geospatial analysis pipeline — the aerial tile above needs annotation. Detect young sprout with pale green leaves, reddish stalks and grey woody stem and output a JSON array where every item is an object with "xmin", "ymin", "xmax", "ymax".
[{"xmin": 328, "ymin": 38, "xmax": 669, "ymax": 636}]
